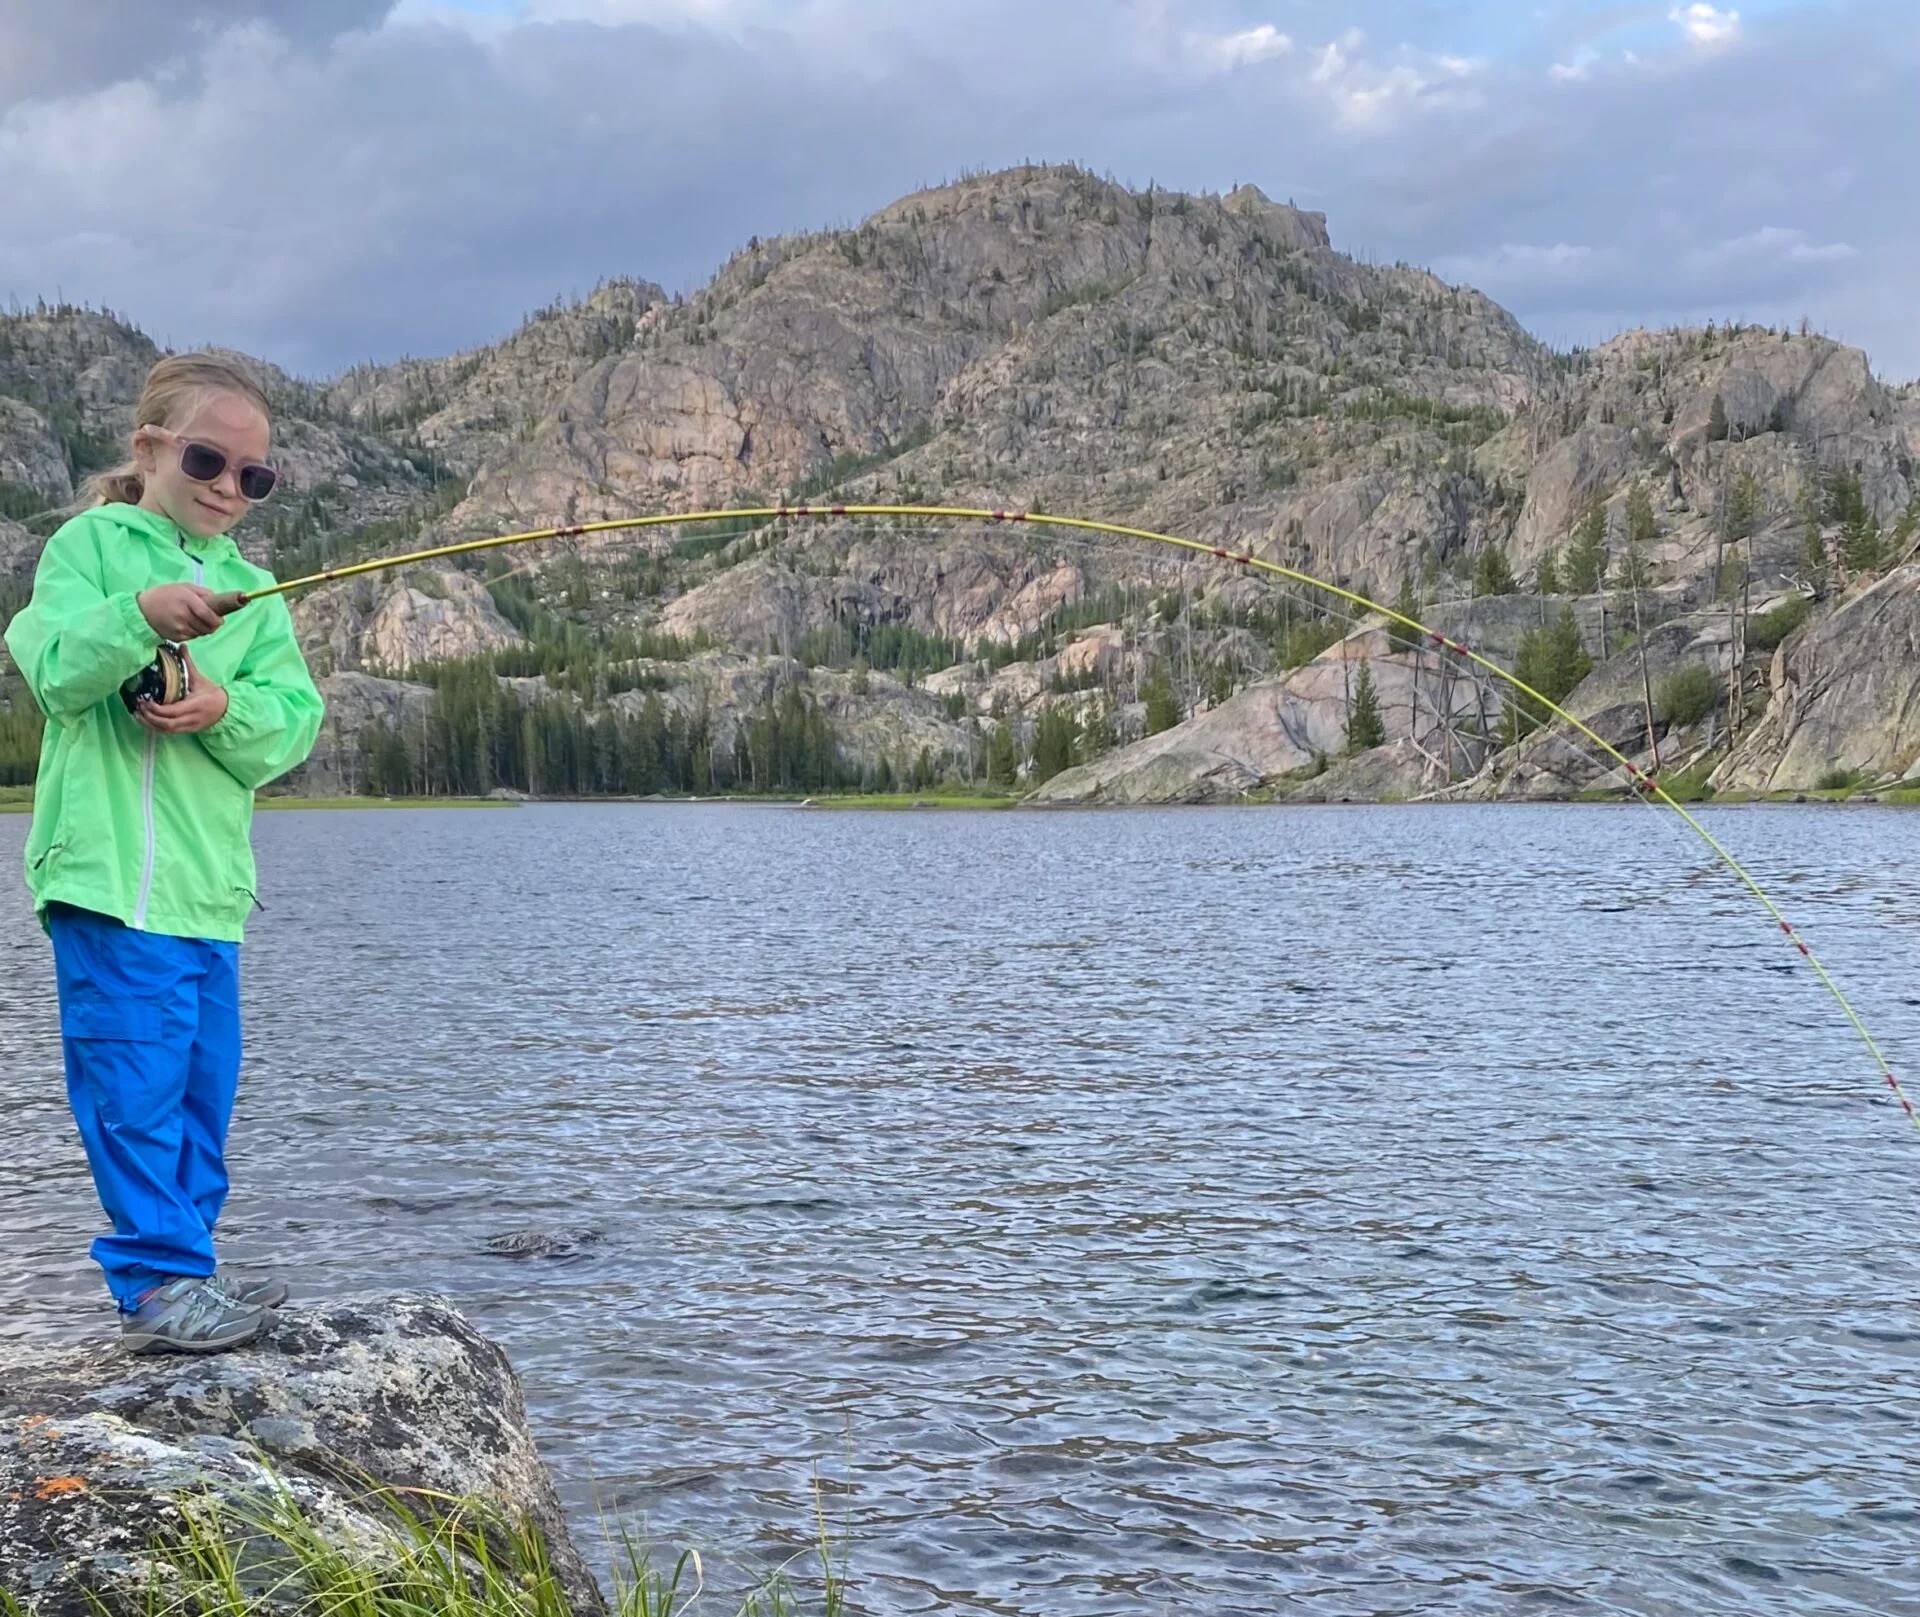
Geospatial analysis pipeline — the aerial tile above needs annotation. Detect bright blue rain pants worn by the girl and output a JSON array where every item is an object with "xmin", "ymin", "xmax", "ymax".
[{"xmin": 48, "ymin": 906, "xmax": 240, "ymax": 1310}]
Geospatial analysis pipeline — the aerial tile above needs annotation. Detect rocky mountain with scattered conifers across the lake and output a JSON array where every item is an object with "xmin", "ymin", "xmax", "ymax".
[{"xmin": 0, "ymin": 167, "xmax": 1920, "ymax": 801}]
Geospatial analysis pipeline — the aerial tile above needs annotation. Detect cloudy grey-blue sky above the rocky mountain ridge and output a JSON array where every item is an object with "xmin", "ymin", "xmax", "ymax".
[{"xmin": 0, "ymin": 0, "xmax": 1920, "ymax": 380}]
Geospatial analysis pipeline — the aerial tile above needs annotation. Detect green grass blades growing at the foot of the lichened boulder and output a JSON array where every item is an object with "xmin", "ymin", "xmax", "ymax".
[{"xmin": 16, "ymin": 1471, "xmax": 849, "ymax": 1617}]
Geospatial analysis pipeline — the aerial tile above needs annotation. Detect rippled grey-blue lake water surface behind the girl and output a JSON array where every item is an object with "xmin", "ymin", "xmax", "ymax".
[{"xmin": 0, "ymin": 807, "xmax": 1920, "ymax": 1617}]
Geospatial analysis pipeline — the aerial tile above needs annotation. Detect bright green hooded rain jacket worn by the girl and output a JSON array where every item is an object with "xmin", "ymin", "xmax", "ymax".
[{"xmin": 6, "ymin": 505, "xmax": 323, "ymax": 943}]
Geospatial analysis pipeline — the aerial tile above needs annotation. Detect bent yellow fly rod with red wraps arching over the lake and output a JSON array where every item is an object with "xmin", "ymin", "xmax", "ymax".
[{"xmin": 176, "ymin": 505, "xmax": 1920, "ymax": 1129}]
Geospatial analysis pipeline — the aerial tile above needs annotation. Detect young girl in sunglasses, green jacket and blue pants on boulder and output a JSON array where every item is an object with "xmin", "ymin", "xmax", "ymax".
[{"xmin": 6, "ymin": 355, "xmax": 321, "ymax": 1352}]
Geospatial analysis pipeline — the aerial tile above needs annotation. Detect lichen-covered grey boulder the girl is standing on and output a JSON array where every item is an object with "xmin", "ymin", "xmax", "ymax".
[{"xmin": 0, "ymin": 1294, "xmax": 603, "ymax": 1617}]
